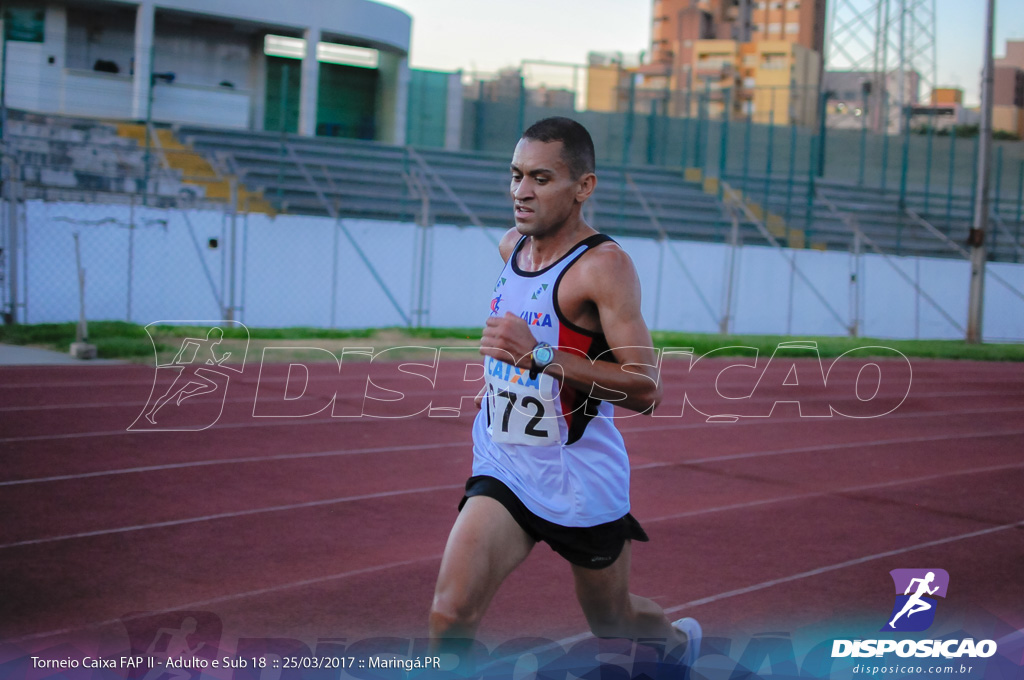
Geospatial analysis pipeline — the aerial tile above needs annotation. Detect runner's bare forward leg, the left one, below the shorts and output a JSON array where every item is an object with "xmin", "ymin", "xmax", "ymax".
[{"xmin": 430, "ymin": 496, "xmax": 534, "ymax": 646}]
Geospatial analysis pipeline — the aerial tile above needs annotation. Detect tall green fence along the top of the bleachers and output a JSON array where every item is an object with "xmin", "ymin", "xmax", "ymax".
[{"xmin": 462, "ymin": 83, "xmax": 1024, "ymax": 233}]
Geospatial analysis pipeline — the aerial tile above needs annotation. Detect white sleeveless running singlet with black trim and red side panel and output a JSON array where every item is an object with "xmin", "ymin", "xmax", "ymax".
[{"xmin": 473, "ymin": 233, "xmax": 630, "ymax": 526}]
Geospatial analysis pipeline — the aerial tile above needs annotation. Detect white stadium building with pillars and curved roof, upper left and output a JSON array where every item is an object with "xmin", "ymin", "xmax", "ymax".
[{"xmin": 5, "ymin": 0, "xmax": 412, "ymax": 142}]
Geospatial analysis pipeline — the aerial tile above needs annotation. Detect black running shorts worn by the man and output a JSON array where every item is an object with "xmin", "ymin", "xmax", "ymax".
[{"xmin": 459, "ymin": 476, "xmax": 649, "ymax": 569}]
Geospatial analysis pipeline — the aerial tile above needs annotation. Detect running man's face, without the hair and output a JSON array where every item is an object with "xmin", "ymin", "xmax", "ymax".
[{"xmin": 510, "ymin": 139, "xmax": 586, "ymax": 236}]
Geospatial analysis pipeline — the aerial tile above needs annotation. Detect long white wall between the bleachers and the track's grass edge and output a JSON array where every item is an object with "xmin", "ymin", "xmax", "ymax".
[{"xmin": 14, "ymin": 202, "xmax": 1024, "ymax": 342}]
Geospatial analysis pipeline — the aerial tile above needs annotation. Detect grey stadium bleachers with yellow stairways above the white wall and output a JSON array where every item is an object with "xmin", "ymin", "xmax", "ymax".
[{"xmin": 6, "ymin": 112, "xmax": 1024, "ymax": 262}]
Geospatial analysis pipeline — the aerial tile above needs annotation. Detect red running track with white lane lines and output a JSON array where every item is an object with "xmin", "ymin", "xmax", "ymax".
[{"xmin": 0, "ymin": 359, "xmax": 1024, "ymax": 649}]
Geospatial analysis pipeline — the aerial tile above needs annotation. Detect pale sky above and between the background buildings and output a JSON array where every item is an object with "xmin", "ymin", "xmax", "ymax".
[{"xmin": 383, "ymin": 0, "xmax": 1024, "ymax": 104}]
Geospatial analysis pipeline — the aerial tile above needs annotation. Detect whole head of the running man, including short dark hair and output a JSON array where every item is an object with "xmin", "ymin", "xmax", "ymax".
[{"xmin": 510, "ymin": 118, "xmax": 597, "ymax": 236}]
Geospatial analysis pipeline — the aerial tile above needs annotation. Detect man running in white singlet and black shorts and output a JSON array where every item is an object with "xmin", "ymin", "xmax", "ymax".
[{"xmin": 429, "ymin": 118, "xmax": 701, "ymax": 666}]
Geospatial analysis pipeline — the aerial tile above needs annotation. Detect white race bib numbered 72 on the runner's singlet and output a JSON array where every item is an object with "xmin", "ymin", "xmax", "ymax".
[{"xmin": 484, "ymin": 357, "xmax": 561, "ymax": 447}]
